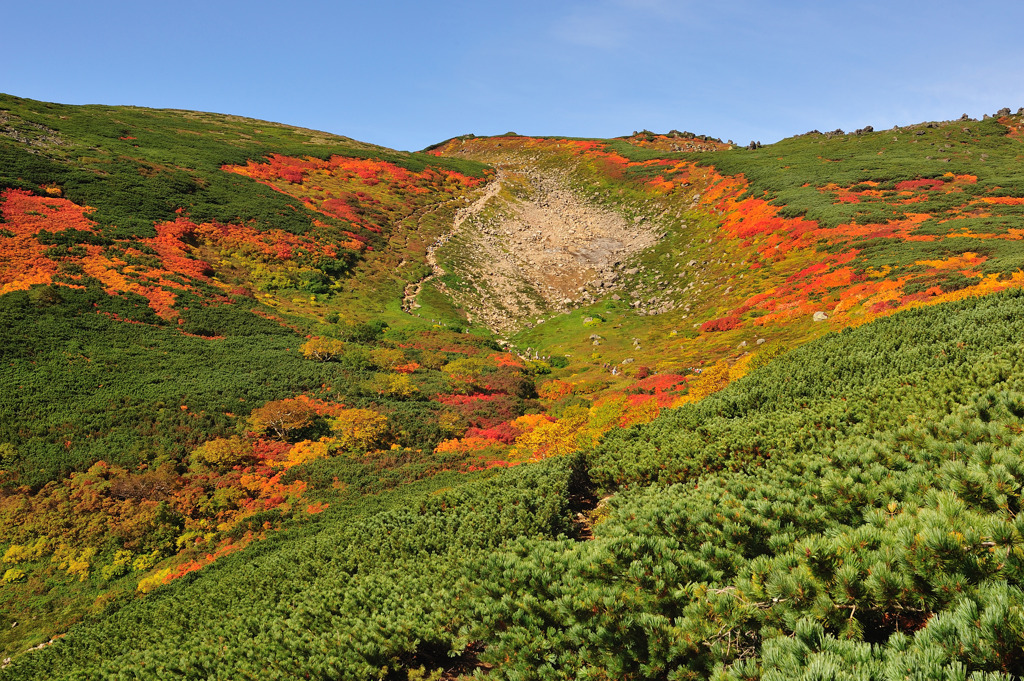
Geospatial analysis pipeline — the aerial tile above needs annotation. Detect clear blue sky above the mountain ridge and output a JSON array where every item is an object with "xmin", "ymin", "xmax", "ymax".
[{"xmin": 0, "ymin": 0, "xmax": 1024, "ymax": 150}]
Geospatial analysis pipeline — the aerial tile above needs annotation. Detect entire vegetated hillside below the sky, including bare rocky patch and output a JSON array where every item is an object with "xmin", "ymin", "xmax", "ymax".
[{"xmin": 0, "ymin": 95, "xmax": 1024, "ymax": 680}]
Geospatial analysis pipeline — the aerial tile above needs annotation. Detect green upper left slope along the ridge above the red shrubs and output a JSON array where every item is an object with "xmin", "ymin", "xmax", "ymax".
[{"xmin": 0, "ymin": 94, "xmax": 484, "ymax": 239}]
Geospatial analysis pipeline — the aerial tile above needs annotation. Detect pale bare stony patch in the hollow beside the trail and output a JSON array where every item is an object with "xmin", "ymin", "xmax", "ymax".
[{"xmin": 425, "ymin": 166, "xmax": 660, "ymax": 334}]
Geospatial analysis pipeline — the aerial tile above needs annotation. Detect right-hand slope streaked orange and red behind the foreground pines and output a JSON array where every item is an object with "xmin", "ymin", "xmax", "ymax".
[{"xmin": 434, "ymin": 115, "xmax": 1024, "ymax": 365}]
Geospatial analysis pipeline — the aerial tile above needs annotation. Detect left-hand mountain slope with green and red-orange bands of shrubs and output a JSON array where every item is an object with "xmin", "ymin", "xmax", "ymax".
[{"xmin": 0, "ymin": 96, "xmax": 503, "ymax": 652}]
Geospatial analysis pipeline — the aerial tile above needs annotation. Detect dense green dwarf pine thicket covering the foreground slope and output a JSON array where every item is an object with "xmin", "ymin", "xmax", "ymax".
[{"xmin": 6, "ymin": 284, "xmax": 1024, "ymax": 679}]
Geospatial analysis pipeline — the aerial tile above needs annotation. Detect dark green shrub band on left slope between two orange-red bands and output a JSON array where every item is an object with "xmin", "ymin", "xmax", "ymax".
[{"xmin": 0, "ymin": 287, "xmax": 512, "ymax": 487}]
